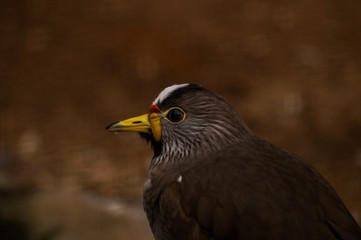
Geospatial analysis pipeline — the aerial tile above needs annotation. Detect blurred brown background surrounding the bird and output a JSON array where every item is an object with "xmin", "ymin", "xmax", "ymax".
[{"xmin": 0, "ymin": 0, "xmax": 361, "ymax": 240}]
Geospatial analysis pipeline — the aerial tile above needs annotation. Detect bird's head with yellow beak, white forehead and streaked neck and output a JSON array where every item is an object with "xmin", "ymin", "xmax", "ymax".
[{"xmin": 107, "ymin": 84, "xmax": 252, "ymax": 164}]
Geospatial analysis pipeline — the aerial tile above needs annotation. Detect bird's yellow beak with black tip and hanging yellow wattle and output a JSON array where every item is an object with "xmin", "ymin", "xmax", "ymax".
[{"xmin": 106, "ymin": 113, "xmax": 162, "ymax": 142}]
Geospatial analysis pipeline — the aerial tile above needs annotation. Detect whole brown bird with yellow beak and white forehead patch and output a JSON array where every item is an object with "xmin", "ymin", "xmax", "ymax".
[{"xmin": 107, "ymin": 83, "xmax": 361, "ymax": 240}]
